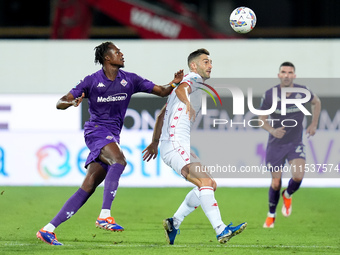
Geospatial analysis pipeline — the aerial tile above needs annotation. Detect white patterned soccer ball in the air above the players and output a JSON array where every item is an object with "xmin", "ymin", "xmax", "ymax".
[{"xmin": 229, "ymin": 7, "xmax": 256, "ymax": 34}]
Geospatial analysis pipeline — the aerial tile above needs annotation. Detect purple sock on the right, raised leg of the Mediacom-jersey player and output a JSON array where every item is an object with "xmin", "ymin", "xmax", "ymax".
[{"xmin": 102, "ymin": 163, "xmax": 125, "ymax": 210}]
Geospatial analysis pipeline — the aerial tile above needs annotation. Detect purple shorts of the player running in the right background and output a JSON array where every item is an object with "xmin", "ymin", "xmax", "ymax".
[{"xmin": 266, "ymin": 143, "xmax": 306, "ymax": 170}]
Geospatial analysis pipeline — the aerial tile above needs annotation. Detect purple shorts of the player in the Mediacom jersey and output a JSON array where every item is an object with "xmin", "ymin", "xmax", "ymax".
[{"xmin": 84, "ymin": 122, "xmax": 119, "ymax": 171}]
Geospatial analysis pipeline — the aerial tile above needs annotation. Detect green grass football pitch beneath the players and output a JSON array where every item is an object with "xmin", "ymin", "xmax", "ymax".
[{"xmin": 0, "ymin": 187, "xmax": 340, "ymax": 255}]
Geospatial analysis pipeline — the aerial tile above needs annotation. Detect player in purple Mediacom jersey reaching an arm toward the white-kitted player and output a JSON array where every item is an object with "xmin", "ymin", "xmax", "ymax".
[{"xmin": 37, "ymin": 42, "xmax": 183, "ymax": 245}]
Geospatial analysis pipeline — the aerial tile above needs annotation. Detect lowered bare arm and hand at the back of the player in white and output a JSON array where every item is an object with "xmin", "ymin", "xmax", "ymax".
[{"xmin": 142, "ymin": 105, "xmax": 166, "ymax": 162}]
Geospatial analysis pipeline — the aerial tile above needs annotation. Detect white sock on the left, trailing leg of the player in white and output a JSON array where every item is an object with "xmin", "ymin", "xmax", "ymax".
[{"xmin": 173, "ymin": 187, "xmax": 201, "ymax": 229}]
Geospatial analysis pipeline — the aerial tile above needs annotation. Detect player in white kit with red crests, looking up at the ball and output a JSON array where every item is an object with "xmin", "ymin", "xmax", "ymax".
[{"xmin": 143, "ymin": 49, "xmax": 247, "ymax": 244}]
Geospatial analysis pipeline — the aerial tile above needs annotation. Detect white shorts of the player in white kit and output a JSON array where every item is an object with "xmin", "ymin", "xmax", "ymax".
[{"xmin": 159, "ymin": 141, "xmax": 200, "ymax": 176}]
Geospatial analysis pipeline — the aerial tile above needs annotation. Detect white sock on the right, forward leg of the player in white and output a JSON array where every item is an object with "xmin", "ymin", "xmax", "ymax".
[{"xmin": 200, "ymin": 186, "xmax": 226, "ymax": 235}]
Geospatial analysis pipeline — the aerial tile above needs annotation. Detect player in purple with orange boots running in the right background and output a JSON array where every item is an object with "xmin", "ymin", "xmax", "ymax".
[{"xmin": 259, "ymin": 62, "xmax": 321, "ymax": 228}]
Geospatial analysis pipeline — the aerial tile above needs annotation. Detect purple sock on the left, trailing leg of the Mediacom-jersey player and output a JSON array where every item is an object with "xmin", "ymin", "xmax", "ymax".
[{"xmin": 50, "ymin": 188, "xmax": 91, "ymax": 227}]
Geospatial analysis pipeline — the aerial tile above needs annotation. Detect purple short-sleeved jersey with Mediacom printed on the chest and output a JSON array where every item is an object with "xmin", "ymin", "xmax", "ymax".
[{"xmin": 70, "ymin": 69, "xmax": 155, "ymax": 135}]
